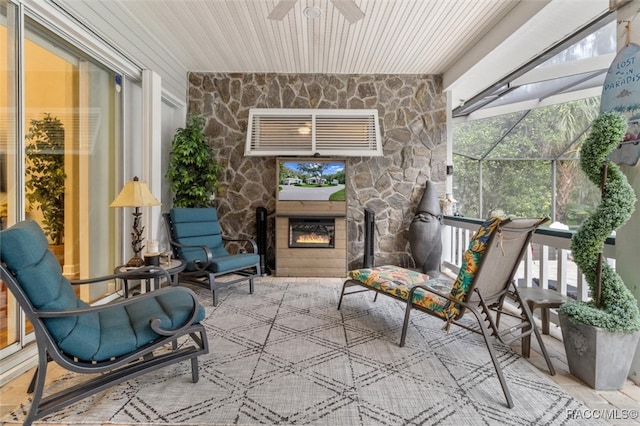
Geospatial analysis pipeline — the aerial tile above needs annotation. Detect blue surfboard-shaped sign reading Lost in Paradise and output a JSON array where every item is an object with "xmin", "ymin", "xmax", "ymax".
[{"xmin": 600, "ymin": 43, "xmax": 640, "ymax": 166}]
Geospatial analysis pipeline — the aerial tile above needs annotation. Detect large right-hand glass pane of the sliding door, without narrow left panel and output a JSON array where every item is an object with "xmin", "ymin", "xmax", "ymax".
[{"xmin": 24, "ymin": 20, "xmax": 120, "ymax": 290}]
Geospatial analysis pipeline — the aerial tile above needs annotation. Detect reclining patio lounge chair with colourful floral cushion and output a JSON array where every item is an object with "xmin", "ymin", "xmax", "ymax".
[{"xmin": 338, "ymin": 217, "xmax": 555, "ymax": 408}]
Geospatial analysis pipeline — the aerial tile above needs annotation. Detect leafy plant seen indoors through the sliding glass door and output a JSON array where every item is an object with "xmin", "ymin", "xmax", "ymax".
[{"xmin": 25, "ymin": 114, "xmax": 67, "ymax": 251}]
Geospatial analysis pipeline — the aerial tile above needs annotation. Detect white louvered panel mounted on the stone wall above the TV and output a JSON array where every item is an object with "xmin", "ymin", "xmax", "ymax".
[{"xmin": 245, "ymin": 108, "xmax": 382, "ymax": 157}]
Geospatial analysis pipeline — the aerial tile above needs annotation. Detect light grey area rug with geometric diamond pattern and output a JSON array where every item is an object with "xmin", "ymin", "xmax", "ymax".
[{"xmin": 4, "ymin": 279, "xmax": 600, "ymax": 425}]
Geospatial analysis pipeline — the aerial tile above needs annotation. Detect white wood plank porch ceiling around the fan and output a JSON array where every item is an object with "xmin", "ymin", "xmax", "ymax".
[{"xmin": 75, "ymin": 0, "xmax": 518, "ymax": 74}]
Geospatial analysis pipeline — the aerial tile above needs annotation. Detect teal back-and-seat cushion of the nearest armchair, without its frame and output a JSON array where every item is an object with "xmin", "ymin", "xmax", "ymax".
[{"xmin": 0, "ymin": 221, "xmax": 204, "ymax": 361}]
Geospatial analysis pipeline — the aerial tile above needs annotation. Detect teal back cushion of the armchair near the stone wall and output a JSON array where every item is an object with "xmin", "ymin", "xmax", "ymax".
[{"xmin": 170, "ymin": 207, "xmax": 229, "ymax": 270}]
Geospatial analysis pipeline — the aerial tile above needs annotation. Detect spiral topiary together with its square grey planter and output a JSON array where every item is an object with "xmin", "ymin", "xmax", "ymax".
[{"xmin": 560, "ymin": 112, "xmax": 640, "ymax": 389}]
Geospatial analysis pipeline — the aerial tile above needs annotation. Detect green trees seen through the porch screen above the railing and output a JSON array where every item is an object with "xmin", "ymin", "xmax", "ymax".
[{"xmin": 453, "ymin": 98, "xmax": 599, "ymax": 228}]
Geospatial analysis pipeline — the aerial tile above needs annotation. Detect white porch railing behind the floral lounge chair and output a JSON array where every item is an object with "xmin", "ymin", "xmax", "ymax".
[{"xmin": 442, "ymin": 216, "xmax": 615, "ymax": 323}]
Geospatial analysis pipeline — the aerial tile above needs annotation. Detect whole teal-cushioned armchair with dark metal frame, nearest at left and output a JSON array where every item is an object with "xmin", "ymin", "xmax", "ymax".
[{"xmin": 0, "ymin": 221, "xmax": 209, "ymax": 424}]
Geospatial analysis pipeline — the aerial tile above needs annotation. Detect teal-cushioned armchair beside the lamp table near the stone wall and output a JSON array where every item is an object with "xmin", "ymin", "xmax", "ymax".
[{"xmin": 164, "ymin": 207, "xmax": 261, "ymax": 306}]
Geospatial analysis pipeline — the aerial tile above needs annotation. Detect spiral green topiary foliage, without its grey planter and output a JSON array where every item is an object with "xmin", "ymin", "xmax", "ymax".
[{"xmin": 560, "ymin": 112, "xmax": 640, "ymax": 332}]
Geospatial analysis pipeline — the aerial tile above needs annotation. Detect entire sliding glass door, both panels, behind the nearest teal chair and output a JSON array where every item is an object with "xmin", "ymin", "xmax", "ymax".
[{"xmin": 0, "ymin": 5, "xmax": 121, "ymax": 360}]
